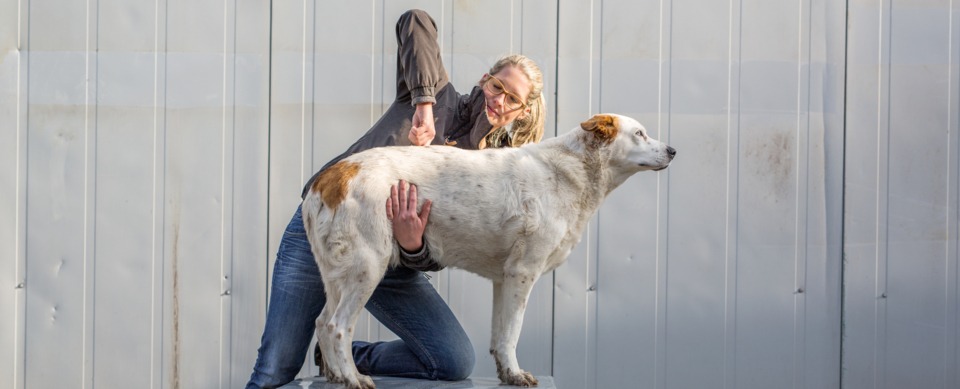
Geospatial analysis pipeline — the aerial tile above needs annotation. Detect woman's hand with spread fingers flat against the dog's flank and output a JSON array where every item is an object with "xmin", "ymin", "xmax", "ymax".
[{"xmin": 387, "ymin": 180, "xmax": 432, "ymax": 253}]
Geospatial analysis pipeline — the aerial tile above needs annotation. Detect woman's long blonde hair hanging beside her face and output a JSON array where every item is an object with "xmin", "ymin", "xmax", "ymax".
[{"xmin": 480, "ymin": 54, "xmax": 546, "ymax": 148}]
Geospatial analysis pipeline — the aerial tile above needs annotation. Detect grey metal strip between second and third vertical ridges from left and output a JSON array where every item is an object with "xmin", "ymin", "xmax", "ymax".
[{"xmin": 94, "ymin": 1, "xmax": 164, "ymax": 388}]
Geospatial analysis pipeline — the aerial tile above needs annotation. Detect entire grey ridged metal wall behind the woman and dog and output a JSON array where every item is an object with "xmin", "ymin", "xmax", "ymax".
[{"xmin": 0, "ymin": 0, "xmax": 960, "ymax": 388}]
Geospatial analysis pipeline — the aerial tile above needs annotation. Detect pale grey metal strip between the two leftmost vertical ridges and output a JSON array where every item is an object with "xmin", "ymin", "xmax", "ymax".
[{"xmin": 24, "ymin": 2, "xmax": 96, "ymax": 386}]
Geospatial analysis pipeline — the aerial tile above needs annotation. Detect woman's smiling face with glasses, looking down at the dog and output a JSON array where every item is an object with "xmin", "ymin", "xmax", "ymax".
[{"xmin": 480, "ymin": 65, "xmax": 530, "ymax": 128}]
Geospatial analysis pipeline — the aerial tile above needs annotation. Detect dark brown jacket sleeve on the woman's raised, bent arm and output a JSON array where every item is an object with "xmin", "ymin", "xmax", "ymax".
[{"xmin": 397, "ymin": 10, "xmax": 449, "ymax": 105}]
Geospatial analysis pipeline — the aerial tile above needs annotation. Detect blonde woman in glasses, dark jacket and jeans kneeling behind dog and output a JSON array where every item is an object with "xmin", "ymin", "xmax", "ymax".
[{"xmin": 247, "ymin": 10, "xmax": 544, "ymax": 388}]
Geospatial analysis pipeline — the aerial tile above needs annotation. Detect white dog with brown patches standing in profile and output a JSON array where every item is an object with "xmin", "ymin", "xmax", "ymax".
[{"xmin": 303, "ymin": 114, "xmax": 676, "ymax": 389}]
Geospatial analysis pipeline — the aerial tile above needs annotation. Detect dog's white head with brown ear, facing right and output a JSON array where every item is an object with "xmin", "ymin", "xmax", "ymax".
[{"xmin": 580, "ymin": 114, "xmax": 677, "ymax": 172}]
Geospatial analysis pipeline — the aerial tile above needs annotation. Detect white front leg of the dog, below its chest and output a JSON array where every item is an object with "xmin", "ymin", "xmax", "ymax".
[{"xmin": 490, "ymin": 273, "xmax": 539, "ymax": 387}]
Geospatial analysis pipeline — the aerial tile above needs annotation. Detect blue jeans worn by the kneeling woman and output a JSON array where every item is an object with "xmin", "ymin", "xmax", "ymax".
[{"xmin": 247, "ymin": 207, "xmax": 475, "ymax": 388}]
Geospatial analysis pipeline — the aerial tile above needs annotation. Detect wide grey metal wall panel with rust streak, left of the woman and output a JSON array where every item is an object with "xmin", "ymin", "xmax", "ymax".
[{"xmin": 0, "ymin": 1, "xmax": 269, "ymax": 387}]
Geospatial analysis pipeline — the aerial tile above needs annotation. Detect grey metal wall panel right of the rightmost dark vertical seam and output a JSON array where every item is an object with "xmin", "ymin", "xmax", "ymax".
[{"xmin": 843, "ymin": 1, "xmax": 960, "ymax": 388}]
